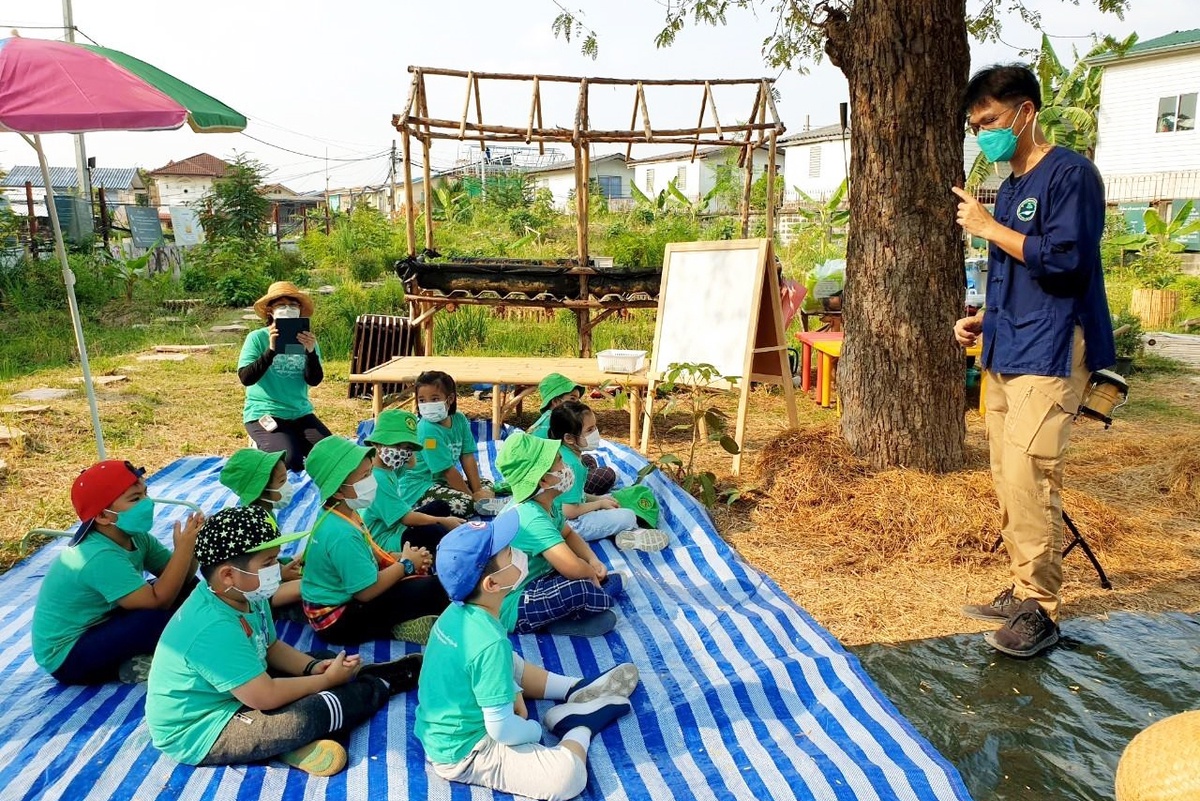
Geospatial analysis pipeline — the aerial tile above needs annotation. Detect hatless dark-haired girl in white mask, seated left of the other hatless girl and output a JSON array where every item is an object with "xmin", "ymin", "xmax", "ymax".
[{"xmin": 412, "ymin": 371, "xmax": 496, "ymax": 518}]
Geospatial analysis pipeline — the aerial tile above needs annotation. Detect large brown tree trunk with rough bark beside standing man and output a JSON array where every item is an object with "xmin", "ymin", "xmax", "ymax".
[{"xmin": 826, "ymin": 0, "xmax": 971, "ymax": 471}]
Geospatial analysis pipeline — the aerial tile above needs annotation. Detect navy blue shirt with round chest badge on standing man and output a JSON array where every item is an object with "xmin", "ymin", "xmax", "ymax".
[{"xmin": 983, "ymin": 147, "xmax": 1116, "ymax": 377}]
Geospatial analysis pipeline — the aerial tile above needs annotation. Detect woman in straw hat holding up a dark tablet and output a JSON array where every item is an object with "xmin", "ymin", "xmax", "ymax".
[{"xmin": 238, "ymin": 281, "xmax": 330, "ymax": 472}]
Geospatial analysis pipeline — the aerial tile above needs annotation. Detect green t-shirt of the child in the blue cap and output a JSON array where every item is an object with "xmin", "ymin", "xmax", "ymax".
[{"xmin": 413, "ymin": 603, "xmax": 516, "ymax": 765}]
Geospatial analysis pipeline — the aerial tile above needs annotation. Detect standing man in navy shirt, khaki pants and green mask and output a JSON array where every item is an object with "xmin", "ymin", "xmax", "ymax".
[{"xmin": 954, "ymin": 65, "xmax": 1116, "ymax": 657}]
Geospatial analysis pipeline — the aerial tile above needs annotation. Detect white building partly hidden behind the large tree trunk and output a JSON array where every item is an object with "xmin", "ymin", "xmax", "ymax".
[{"xmin": 779, "ymin": 125, "xmax": 1010, "ymax": 203}]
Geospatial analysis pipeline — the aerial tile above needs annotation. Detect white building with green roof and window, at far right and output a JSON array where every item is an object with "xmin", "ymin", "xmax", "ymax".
[{"xmin": 1088, "ymin": 29, "xmax": 1200, "ymax": 204}]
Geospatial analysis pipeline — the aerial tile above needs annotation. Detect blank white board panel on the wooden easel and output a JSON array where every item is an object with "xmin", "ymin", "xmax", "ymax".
[{"xmin": 650, "ymin": 239, "xmax": 768, "ymax": 377}]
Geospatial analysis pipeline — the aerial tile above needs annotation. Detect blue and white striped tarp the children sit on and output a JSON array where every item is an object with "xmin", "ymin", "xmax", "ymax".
[{"xmin": 0, "ymin": 431, "xmax": 970, "ymax": 801}]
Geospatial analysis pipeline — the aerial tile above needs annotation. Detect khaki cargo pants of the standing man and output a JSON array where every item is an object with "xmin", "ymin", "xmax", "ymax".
[{"xmin": 985, "ymin": 327, "xmax": 1091, "ymax": 619}]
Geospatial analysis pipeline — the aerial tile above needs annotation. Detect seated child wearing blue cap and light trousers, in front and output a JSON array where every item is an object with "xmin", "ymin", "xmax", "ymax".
[{"xmin": 414, "ymin": 510, "xmax": 637, "ymax": 799}]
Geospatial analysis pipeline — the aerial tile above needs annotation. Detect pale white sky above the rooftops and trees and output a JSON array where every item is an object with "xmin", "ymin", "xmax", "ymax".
[{"xmin": 0, "ymin": 0, "xmax": 1198, "ymax": 191}]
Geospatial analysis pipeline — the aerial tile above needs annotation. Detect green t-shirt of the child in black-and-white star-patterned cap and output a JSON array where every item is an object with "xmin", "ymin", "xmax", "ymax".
[{"xmin": 146, "ymin": 584, "xmax": 275, "ymax": 765}]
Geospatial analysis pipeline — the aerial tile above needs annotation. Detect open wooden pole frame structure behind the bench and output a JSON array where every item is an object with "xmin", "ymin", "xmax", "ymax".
[{"xmin": 391, "ymin": 66, "xmax": 784, "ymax": 355}]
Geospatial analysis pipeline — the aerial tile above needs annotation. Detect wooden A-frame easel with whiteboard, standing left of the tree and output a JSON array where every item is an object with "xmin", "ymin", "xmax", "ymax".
[{"xmin": 641, "ymin": 239, "xmax": 799, "ymax": 475}]
